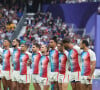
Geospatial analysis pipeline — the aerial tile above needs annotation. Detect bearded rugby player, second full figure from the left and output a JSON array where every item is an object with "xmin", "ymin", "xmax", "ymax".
[{"xmin": 12, "ymin": 39, "xmax": 20, "ymax": 90}]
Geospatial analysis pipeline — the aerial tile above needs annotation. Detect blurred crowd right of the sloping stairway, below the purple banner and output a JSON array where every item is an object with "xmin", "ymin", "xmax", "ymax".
[{"xmin": 20, "ymin": 12, "xmax": 94, "ymax": 52}]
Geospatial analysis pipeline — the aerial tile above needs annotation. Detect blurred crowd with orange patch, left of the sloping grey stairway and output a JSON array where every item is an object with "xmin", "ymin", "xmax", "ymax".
[{"xmin": 0, "ymin": 4, "xmax": 23, "ymax": 47}]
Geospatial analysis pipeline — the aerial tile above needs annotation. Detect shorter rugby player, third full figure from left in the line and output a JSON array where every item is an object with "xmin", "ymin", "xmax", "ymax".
[{"xmin": 19, "ymin": 43, "xmax": 31, "ymax": 90}]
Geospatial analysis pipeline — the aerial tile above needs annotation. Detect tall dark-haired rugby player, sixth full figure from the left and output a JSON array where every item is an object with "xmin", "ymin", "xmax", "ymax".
[{"xmin": 49, "ymin": 36, "xmax": 59, "ymax": 90}]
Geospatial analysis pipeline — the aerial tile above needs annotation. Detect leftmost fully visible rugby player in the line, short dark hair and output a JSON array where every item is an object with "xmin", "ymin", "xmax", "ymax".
[{"xmin": 2, "ymin": 39, "xmax": 12, "ymax": 90}]
